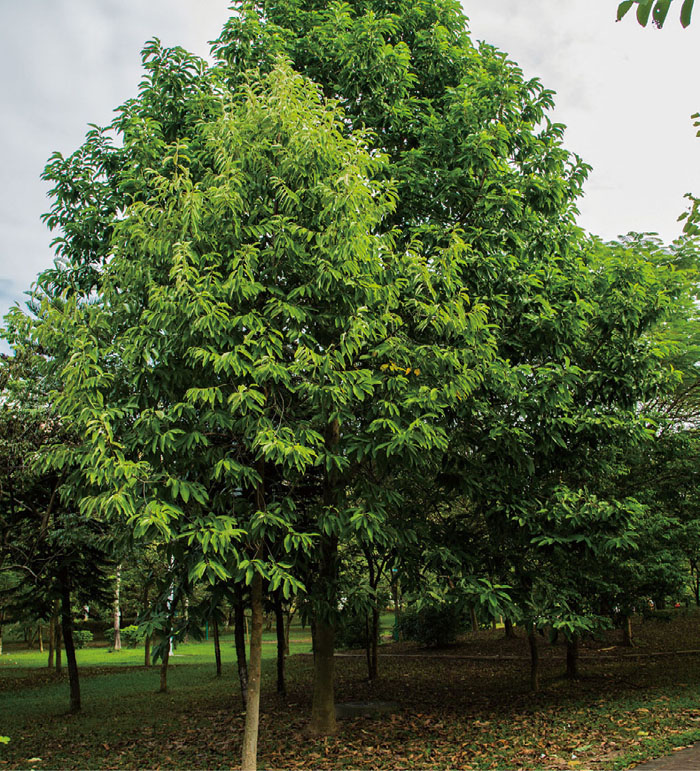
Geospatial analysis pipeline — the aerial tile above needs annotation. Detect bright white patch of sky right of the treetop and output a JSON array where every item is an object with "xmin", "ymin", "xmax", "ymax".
[{"xmin": 463, "ymin": 0, "xmax": 700, "ymax": 240}]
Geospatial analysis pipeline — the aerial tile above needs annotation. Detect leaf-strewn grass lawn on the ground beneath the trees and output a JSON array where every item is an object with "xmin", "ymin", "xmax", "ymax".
[{"xmin": 0, "ymin": 613, "xmax": 700, "ymax": 769}]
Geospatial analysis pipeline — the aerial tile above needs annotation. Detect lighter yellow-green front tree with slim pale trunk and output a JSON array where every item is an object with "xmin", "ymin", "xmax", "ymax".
[{"xmin": 38, "ymin": 47, "xmax": 492, "ymax": 767}]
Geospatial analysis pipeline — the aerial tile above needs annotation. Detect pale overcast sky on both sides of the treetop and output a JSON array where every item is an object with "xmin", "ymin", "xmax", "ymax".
[{"xmin": 0, "ymin": 0, "xmax": 700, "ymax": 347}]
